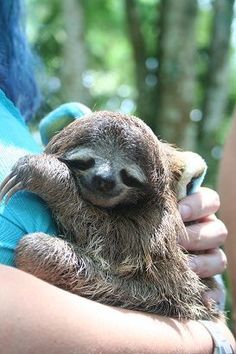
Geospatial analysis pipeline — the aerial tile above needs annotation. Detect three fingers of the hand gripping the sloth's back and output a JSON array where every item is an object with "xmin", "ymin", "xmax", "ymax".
[{"xmin": 179, "ymin": 188, "xmax": 227, "ymax": 278}]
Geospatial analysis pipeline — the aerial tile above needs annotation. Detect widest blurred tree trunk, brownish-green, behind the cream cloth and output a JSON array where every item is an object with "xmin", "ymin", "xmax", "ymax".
[{"xmin": 157, "ymin": 0, "xmax": 197, "ymax": 149}]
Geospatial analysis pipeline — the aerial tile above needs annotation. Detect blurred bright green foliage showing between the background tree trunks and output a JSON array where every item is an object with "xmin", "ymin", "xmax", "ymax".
[{"xmin": 24, "ymin": 0, "xmax": 236, "ymax": 186}]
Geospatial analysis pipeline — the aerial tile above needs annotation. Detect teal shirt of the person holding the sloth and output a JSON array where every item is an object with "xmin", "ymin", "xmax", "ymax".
[{"xmin": 0, "ymin": 90, "xmax": 57, "ymax": 266}]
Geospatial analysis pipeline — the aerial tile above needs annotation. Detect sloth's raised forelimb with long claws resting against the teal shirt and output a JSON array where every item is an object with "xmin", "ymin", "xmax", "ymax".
[{"xmin": 0, "ymin": 154, "xmax": 73, "ymax": 207}]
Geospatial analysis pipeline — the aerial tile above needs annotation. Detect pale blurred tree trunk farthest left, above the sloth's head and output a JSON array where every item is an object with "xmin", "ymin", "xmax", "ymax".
[{"xmin": 62, "ymin": 0, "xmax": 90, "ymax": 104}]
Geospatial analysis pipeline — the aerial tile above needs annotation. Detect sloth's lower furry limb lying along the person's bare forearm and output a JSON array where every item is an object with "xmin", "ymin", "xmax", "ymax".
[{"xmin": 15, "ymin": 233, "xmax": 138, "ymax": 308}]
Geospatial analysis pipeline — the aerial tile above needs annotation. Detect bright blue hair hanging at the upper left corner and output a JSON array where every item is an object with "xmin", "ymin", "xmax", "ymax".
[{"xmin": 0, "ymin": 0, "xmax": 40, "ymax": 121}]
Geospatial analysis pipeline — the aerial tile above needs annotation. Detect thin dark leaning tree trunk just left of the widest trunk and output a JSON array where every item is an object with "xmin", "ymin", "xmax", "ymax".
[{"xmin": 125, "ymin": 0, "xmax": 157, "ymax": 129}]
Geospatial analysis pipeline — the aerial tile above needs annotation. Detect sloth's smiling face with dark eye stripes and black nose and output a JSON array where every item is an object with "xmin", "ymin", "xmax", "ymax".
[{"xmin": 60, "ymin": 145, "xmax": 151, "ymax": 208}]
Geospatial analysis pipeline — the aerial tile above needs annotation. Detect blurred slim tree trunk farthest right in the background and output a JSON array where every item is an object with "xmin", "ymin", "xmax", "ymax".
[{"xmin": 199, "ymin": 0, "xmax": 234, "ymax": 142}]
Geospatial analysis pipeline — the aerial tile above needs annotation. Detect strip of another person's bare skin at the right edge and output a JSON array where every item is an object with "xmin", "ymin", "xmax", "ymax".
[{"xmin": 219, "ymin": 112, "xmax": 236, "ymax": 335}]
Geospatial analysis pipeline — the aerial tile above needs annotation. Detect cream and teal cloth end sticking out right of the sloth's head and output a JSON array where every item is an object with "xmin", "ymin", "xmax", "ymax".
[{"xmin": 174, "ymin": 151, "xmax": 207, "ymax": 200}]
